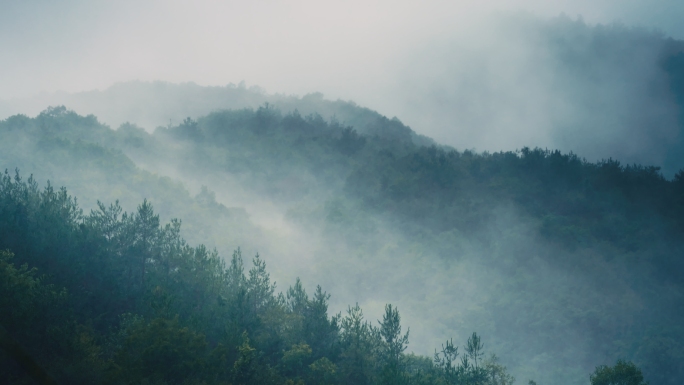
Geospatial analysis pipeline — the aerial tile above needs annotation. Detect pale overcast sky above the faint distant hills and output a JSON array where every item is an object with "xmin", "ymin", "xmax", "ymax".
[{"xmin": 0, "ymin": 0, "xmax": 684, "ymax": 99}]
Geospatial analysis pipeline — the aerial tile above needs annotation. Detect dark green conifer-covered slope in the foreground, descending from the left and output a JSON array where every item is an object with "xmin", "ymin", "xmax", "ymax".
[{"xmin": 0, "ymin": 173, "xmax": 512, "ymax": 385}]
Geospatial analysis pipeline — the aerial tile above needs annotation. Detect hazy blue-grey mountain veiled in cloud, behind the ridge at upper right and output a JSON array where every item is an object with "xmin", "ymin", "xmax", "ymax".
[{"xmin": 384, "ymin": 13, "xmax": 684, "ymax": 174}]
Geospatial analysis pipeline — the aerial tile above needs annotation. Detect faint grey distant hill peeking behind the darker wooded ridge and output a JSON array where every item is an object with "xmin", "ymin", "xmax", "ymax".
[{"xmin": 0, "ymin": 81, "xmax": 434, "ymax": 144}]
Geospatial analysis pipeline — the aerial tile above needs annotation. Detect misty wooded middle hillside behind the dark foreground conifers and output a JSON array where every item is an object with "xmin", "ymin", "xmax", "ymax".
[{"xmin": 0, "ymin": 106, "xmax": 684, "ymax": 384}]
